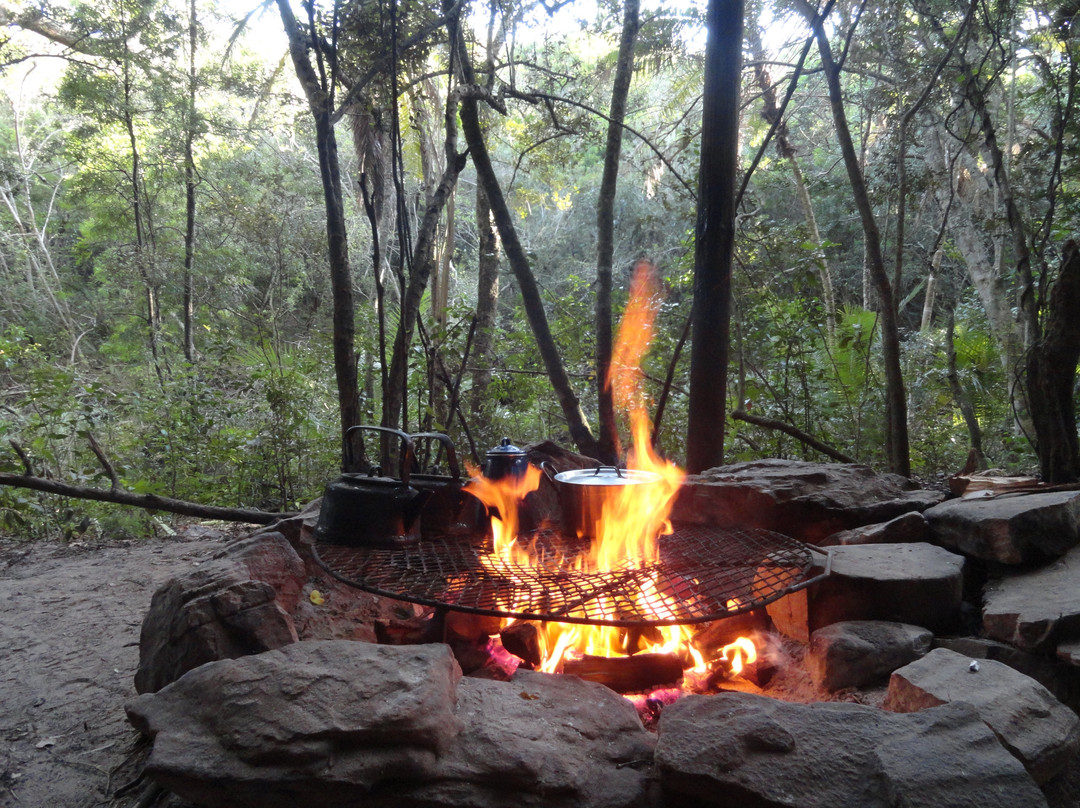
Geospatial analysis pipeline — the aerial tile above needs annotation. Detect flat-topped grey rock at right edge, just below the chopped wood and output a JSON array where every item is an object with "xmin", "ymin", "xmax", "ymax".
[{"xmin": 924, "ymin": 491, "xmax": 1080, "ymax": 564}]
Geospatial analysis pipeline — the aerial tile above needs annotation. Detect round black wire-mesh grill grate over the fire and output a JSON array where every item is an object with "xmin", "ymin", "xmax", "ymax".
[{"xmin": 314, "ymin": 525, "xmax": 813, "ymax": 627}]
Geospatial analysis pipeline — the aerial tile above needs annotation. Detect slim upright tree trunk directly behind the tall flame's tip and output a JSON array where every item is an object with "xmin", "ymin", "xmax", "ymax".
[{"xmin": 596, "ymin": 0, "xmax": 640, "ymax": 463}]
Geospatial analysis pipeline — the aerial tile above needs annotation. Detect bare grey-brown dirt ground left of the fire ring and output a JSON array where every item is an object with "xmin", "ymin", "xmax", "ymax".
[{"xmin": 0, "ymin": 525, "xmax": 240, "ymax": 808}]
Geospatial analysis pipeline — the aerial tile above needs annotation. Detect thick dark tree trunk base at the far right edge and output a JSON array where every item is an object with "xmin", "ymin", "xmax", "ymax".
[{"xmin": 1026, "ymin": 240, "xmax": 1080, "ymax": 485}]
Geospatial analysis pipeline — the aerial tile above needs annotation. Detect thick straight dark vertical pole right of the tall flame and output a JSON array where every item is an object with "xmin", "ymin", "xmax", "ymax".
[{"xmin": 687, "ymin": 0, "xmax": 743, "ymax": 473}]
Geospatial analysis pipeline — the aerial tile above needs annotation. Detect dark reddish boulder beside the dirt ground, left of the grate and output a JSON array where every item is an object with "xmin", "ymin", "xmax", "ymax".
[{"xmin": 135, "ymin": 533, "xmax": 307, "ymax": 692}]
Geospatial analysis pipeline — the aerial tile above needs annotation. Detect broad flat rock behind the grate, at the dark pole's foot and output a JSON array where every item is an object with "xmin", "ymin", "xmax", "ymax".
[{"xmin": 672, "ymin": 460, "xmax": 943, "ymax": 542}]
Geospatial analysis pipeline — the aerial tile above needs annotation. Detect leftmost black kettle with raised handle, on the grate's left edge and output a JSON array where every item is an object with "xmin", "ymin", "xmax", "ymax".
[{"xmin": 315, "ymin": 426, "xmax": 430, "ymax": 549}]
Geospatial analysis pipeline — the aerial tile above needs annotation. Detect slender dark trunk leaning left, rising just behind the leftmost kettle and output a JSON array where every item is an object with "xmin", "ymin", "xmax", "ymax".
[{"xmin": 278, "ymin": 0, "xmax": 363, "ymax": 471}]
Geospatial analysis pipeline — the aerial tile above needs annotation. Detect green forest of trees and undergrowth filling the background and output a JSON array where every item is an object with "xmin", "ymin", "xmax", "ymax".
[{"xmin": 0, "ymin": 0, "xmax": 1080, "ymax": 536}]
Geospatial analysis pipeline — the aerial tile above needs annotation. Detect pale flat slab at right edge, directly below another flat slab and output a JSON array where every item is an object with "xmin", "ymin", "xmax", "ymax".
[{"xmin": 983, "ymin": 548, "xmax": 1080, "ymax": 650}]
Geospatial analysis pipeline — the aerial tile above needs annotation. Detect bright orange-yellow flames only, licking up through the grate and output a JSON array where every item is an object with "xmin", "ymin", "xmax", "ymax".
[{"xmin": 467, "ymin": 261, "xmax": 756, "ymax": 673}]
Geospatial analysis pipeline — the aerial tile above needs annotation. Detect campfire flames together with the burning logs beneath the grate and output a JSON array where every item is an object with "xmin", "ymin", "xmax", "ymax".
[{"xmin": 447, "ymin": 262, "xmax": 757, "ymax": 690}]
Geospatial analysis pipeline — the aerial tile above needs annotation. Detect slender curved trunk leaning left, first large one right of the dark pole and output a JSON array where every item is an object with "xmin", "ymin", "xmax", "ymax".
[{"xmin": 802, "ymin": 4, "xmax": 912, "ymax": 476}]
